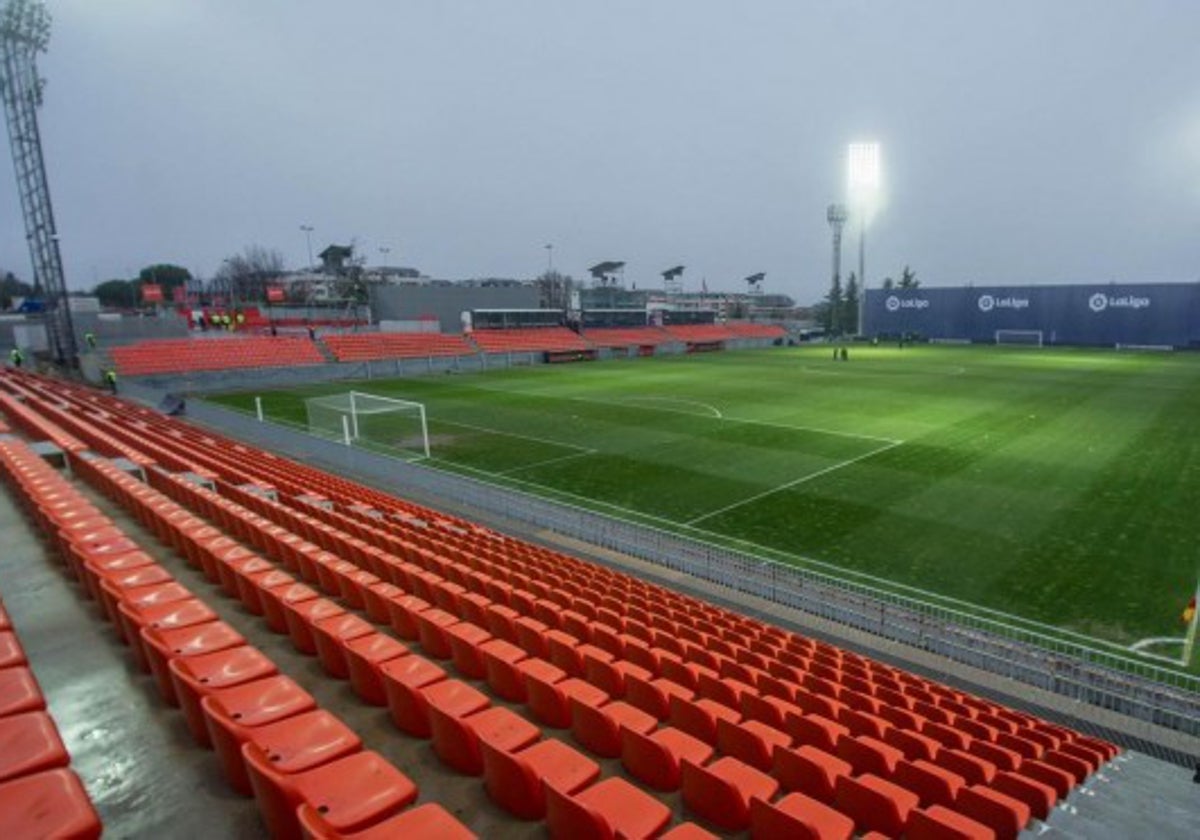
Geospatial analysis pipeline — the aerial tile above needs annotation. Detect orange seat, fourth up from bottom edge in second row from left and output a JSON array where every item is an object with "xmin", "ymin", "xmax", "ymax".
[{"xmin": 200, "ymin": 676, "xmax": 317, "ymax": 797}]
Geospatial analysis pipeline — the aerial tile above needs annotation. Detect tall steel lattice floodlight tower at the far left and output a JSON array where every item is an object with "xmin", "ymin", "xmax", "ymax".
[{"xmin": 0, "ymin": 0, "xmax": 78, "ymax": 367}]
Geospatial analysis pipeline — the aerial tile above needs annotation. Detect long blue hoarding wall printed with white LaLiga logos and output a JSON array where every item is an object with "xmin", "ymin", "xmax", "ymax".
[{"xmin": 865, "ymin": 283, "xmax": 1200, "ymax": 347}]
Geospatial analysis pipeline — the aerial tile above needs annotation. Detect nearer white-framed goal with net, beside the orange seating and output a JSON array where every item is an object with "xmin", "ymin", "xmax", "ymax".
[{"xmin": 304, "ymin": 391, "xmax": 430, "ymax": 458}]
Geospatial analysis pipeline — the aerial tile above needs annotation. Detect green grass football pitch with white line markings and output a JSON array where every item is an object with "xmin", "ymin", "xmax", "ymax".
[{"xmin": 217, "ymin": 347, "xmax": 1200, "ymax": 643}]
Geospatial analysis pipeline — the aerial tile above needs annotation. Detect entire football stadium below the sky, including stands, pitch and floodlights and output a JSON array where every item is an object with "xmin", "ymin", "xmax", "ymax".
[{"xmin": 0, "ymin": 0, "xmax": 1200, "ymax": 840}]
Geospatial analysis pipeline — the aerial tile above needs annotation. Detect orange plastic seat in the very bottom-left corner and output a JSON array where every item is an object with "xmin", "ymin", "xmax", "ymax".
[{"xmin": 0, "ymin": 768, "xmax": 101, "ymax": 840}]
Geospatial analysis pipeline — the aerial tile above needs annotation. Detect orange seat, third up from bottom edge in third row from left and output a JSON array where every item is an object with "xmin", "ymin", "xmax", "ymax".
[{"xmin": 481, "ymin": 738, "xmax": 600, "ymax": 820}]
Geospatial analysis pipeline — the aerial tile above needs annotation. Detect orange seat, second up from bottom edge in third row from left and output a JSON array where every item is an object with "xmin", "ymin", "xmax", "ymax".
[{"xmin": 545, "ymin": 776, "xmax": 671, "ymax": 840}]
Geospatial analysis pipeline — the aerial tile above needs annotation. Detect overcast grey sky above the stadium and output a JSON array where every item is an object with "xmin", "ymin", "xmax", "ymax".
[{"xmin": 0, "ymin": 0, "xmax": 1200, "ymax": 302}]
